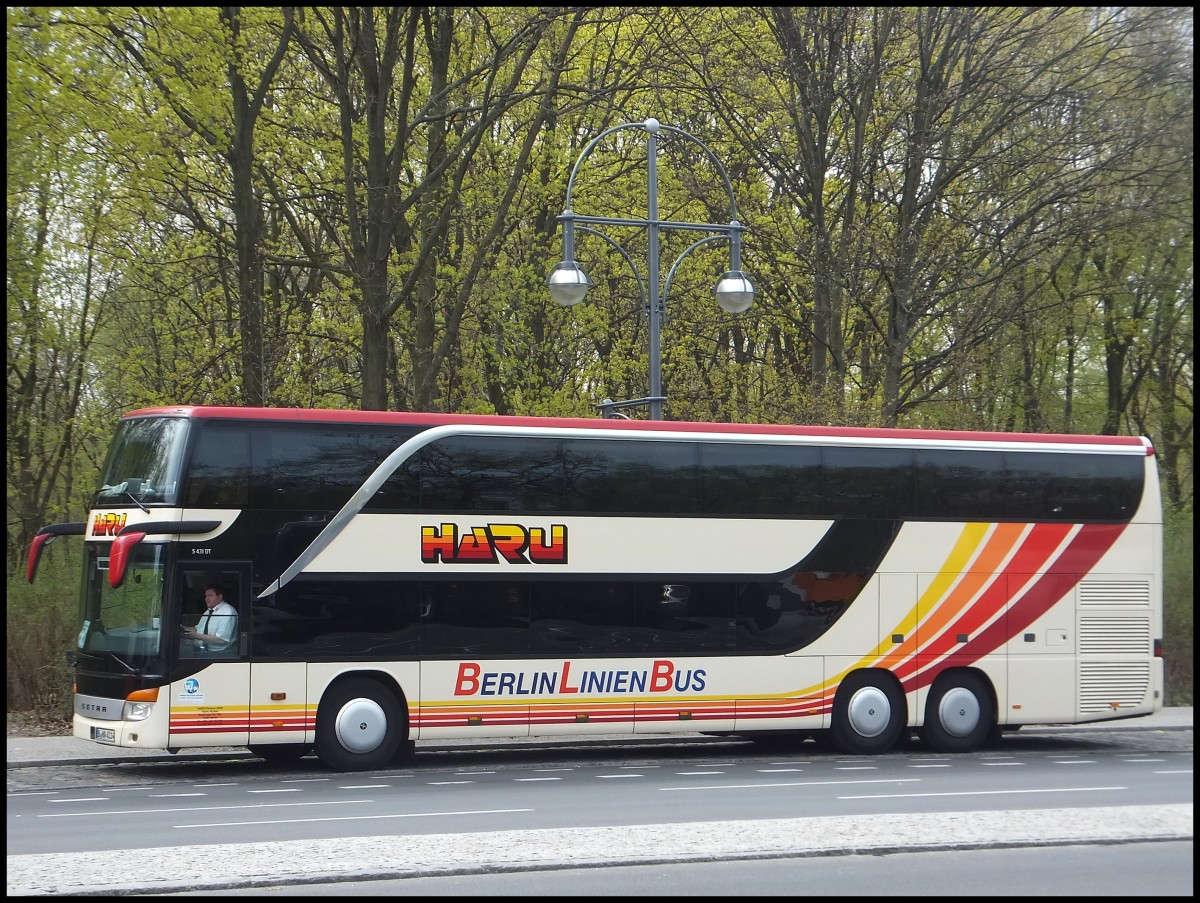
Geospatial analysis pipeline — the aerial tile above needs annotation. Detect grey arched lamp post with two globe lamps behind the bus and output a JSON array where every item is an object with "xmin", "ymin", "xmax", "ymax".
[{"xmin": 546, "ymin": 119, "xmax": 755, "ymax": 420}]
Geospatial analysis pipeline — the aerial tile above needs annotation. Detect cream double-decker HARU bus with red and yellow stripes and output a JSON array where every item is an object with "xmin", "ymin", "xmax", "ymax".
[{"xmin": 28, "ymin": 407, "xmax": 1163, "ymax": 771}]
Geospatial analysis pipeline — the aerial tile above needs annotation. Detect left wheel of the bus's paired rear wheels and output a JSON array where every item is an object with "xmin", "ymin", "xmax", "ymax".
[{"xmin": 829, "ymin": 670, "xmax": 908, "ymax": 755}]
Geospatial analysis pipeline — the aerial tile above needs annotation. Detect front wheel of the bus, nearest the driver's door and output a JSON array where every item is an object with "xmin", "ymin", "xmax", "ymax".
[{"xmin": 317, "ymin": 677, "xmax": 408, "ymax": 771}]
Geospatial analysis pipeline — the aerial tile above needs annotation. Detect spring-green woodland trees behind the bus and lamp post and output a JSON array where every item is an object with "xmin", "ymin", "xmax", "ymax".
[{"xmin": 7, "ymin": 7, "xmax": 1194, "ymax": 715}]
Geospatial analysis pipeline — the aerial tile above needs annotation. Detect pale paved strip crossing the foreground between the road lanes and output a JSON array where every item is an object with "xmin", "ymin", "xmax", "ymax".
[{"xmin": 7, "ymin": 803, "xmax": 1193, "ymax": 896}]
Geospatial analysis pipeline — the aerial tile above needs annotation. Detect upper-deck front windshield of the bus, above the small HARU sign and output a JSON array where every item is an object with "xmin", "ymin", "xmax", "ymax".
[{"xmin": 94, "ymin": 418, "xmax": 187, "ymax": 507}]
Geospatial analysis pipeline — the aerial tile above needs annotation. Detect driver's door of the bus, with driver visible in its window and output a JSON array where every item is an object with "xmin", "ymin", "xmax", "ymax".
[{"xmin": 164, "ymin": 561, "xmax": 250, "ymax": 748}]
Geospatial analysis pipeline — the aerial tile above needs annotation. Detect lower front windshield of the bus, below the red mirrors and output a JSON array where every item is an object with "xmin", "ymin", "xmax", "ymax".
[{"xmin": 76, "ymin": 543, "xmax": 174, "ymax": 675}]
